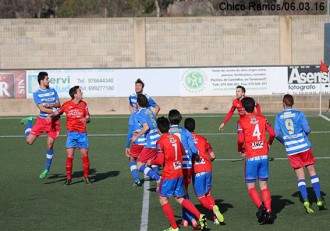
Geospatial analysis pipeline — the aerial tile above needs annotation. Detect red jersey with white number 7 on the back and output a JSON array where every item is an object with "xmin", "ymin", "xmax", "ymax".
[{"xmin": 152, "ymin": 133, "xmax": 185, "ymax": 179}]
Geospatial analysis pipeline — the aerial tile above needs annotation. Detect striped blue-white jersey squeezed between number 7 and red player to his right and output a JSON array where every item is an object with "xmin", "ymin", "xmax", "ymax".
[{"xmin": 169, "ymin": 125, "xmax": 198, "ymax": 169}]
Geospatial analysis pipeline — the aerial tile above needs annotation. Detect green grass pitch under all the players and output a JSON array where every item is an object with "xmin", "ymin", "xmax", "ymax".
[{"xmin": 0, "ymin": 114, "xmax": 330, "ymax": 231}]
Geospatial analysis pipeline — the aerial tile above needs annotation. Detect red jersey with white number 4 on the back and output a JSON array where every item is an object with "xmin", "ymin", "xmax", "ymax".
[{"xmin": 237, "ymin": 113, "xmax": 275, "ymax": 158}]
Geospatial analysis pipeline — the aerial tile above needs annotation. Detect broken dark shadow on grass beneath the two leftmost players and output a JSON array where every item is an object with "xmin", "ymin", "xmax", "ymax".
[{"xmin": 45, "ymin": 168, "xmax": 120, "ymax": 184}]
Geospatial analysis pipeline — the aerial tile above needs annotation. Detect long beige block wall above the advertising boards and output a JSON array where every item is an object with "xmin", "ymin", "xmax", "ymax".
[{"xmin": 0, "ymin": 15, "xmax": 326, "ymax": 69}]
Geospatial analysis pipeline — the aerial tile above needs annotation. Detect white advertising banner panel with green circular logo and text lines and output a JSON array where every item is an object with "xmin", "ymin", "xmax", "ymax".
[{"xmin": 180, "ymin": 67, "xmax": 287, "ymax": 96}]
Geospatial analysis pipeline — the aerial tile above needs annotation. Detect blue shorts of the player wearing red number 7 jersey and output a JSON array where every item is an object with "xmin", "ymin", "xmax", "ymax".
[{"xmin": 158, "ymin": 177, "xmax": 184, "ymax": 197}]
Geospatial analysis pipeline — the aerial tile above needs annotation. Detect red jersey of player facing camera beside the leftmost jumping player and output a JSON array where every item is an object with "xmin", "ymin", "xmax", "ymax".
[{"xmin": 59, "ymin": 100, "xmax": 89, "ymax": 132}]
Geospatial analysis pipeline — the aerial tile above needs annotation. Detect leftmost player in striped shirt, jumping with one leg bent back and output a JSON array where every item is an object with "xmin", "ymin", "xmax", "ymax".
[{"xmin": 21, "ymin": 72, "xmax": 61, "ymax": 179}]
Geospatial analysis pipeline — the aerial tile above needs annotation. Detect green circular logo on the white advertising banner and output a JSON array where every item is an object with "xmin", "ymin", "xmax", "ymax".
[{"xmin": 183, "ymin": 70, "xmax": 206, "ymax": 93}]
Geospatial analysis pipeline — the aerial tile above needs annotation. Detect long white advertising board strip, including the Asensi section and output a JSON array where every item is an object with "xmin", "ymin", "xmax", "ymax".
[{"xmin": 26, "ymin": 66, "xmax": 330, "ymax": 98}]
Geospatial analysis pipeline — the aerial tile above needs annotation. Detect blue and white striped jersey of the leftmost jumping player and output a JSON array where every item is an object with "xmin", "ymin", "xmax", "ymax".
[{"xmin": 33, "ymin": 87, "xmax": 59, "ymax": 118}]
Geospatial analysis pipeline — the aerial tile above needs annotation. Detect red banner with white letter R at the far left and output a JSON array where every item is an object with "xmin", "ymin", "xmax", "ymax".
[{"xmin": 0, "ymin": 70, "xmax": 26, "ymax": 99}]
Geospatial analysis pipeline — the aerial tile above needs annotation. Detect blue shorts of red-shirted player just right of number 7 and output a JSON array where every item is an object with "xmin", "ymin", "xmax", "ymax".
[{"xmin": 192, "ymin": 172, "xmax": 212, "ymax": 197}]
